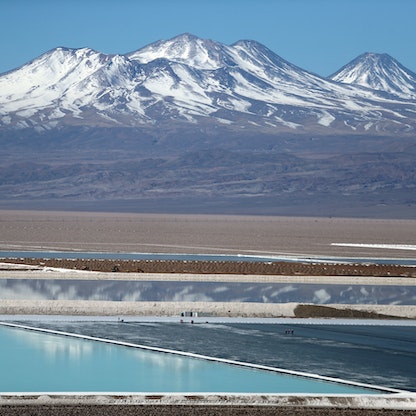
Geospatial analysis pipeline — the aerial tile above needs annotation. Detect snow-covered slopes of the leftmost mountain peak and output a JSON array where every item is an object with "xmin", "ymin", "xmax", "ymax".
[{"xmin": 0, "ymin": 48, "xmax": 154, "ymax": 127}]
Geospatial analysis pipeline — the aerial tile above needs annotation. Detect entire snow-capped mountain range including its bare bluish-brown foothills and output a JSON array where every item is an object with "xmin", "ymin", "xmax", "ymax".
[{"xmin": 0, "ymin": 34, "xmax": 416, "ymax": 218}]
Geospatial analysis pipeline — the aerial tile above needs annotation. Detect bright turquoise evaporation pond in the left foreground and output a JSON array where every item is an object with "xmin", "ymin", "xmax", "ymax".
[{"xmin": 0, "ymin": 326, "xmax": 378, "ymax": 394}]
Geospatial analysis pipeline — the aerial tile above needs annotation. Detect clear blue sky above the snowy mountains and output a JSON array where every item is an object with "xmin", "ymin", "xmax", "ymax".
[{"xmin": 0, "ymin": 0, "xmax": 416, "ymax": 76}]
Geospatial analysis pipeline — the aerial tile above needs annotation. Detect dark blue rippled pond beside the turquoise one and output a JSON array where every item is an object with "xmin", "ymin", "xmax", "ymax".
[{"xmin": 18, "ymin": 320, "xmax": 416, "ymax": 391}]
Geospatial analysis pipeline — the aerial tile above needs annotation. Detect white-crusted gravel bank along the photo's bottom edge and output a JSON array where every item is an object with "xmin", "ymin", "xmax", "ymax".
[{"xmin": 0, "ymin": 393, "xmax": 416, "ymax": 416}]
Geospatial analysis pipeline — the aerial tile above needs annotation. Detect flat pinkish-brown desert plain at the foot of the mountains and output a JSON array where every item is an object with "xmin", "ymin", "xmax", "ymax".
[{"xmin": 0, "ymin": 211, "xmax": 416, "ymax": 258}]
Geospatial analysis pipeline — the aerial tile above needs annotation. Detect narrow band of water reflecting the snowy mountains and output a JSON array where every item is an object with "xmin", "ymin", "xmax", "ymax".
[{"xmin": 0, "ymin": 279, "xmax": 416, "ymax": 305}]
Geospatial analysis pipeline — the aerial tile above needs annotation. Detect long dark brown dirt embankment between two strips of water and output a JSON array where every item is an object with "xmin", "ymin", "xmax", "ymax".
[{"xmin": 0, "ymin": 258, "xmax": 416, "ymax": 277}]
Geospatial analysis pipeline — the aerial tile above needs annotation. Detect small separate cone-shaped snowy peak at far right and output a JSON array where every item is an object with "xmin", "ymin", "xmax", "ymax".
[{"xmin": 330, "ymin": 53, "xmax": 416, "ymax": 99}]
